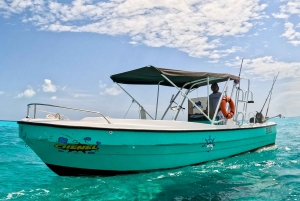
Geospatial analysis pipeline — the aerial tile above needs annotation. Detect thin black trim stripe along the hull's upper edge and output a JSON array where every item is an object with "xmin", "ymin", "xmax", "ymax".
[{"xmin": 18, "ymin": 121, "xmax": 277, "ymax": 133}]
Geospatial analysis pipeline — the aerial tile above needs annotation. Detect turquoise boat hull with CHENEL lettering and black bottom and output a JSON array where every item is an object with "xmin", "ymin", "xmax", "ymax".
[{"xmin": 18, "ymin": 121, "xmax": 276, "ymax": 176}]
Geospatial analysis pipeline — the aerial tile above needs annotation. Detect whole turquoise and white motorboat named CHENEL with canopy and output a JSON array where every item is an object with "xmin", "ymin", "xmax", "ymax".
[{"xmin": 18, "ymin": 66, "xmax": 277, "ymax": 176}]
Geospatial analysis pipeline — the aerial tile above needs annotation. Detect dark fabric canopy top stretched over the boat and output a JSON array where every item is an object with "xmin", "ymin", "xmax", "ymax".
[{"xmin": 110, "ymin": 66, "xmax": 239, "ymax": 89}]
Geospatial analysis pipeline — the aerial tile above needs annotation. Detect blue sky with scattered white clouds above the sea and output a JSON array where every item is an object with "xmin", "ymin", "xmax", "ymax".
[{"xmin": 0, "ymin": 0, "xmax": 300, "ymax": 120}]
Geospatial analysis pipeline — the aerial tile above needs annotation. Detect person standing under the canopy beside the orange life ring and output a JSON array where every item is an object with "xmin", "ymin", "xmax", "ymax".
[{"xmin": 204, "ymin": 82, "xmax": 222, "ymax": 120}]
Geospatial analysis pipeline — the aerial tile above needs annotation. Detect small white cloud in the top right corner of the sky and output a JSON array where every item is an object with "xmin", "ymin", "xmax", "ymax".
[{"xmin": 273, "ymin": 0, "xmax": 300, "ymax": 46}]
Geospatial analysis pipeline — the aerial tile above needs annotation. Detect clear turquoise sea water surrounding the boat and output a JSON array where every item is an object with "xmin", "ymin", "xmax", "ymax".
[{"xmin": 0, "ymin": 117, "xmax": 300, "ymax": 201}]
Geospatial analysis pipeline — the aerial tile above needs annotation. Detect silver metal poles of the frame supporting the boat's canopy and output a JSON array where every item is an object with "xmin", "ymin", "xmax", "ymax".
[{"xmin": 111, "ymin": 66, "xmax": 243, "ymax": 124}]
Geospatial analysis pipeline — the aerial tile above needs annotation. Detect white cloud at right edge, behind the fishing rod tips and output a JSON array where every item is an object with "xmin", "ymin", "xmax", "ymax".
[{"xmin": 226, "ymin": 56, "xmax": 300, "ymax": 80}]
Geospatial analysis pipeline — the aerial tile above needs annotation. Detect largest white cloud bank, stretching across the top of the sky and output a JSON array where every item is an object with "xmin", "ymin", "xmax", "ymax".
[{"xmin": 0, "ymin": 0, "xmax": 266, "ymax": 59}]
